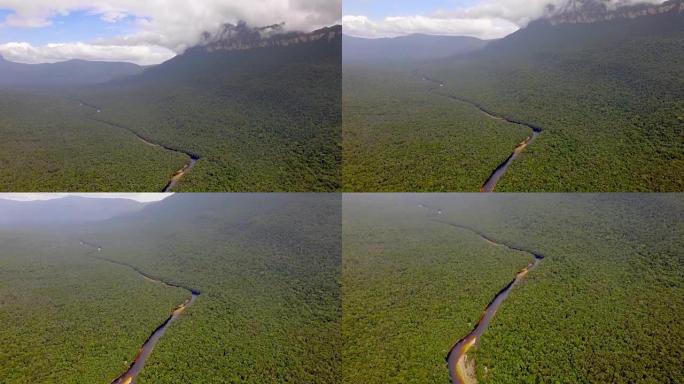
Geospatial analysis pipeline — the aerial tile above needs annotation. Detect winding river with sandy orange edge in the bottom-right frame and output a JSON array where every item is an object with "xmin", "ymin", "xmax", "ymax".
[{"xmin": 420, "ymin": 204, "xmax": 544, "ymax": 384}]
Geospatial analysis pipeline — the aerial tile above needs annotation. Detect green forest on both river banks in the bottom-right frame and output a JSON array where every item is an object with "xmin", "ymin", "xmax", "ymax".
[{"xmin": 343, "ymin": 194, "xmax": 684, "ymax": 383}]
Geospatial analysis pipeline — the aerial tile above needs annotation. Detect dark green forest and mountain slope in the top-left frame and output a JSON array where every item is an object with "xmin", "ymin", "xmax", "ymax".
[{"xmin": 0, "ymin": 27, "xmax": 342, "ymax": 191}]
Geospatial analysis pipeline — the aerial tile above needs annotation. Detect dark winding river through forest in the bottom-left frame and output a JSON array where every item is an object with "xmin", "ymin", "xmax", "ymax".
[{"xmin": 80, "ymin": 240, "xmax": 200, "ymax": 384}]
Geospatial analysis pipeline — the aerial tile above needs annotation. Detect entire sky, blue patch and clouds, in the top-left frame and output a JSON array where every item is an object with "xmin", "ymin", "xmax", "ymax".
[{"xmin": 0, "ymin": 0, "xmax": 342, "ymax": 65}]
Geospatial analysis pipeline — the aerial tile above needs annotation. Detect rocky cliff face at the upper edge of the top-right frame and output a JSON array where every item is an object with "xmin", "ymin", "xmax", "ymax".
[{"xmin": 547, "ymin": 0, "xmax": 684, "ymax": 25}]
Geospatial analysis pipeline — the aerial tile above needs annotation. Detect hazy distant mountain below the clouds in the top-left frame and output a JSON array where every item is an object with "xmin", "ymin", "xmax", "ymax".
[{"xmin": 0, "ymin": 56, "xmax": 143, "ymax": 87}]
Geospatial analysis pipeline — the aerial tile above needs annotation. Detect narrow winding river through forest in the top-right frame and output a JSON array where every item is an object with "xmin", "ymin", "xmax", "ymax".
[{"xmin": 423, "ymin": 76, "xmax": 542, "ymax": 192}]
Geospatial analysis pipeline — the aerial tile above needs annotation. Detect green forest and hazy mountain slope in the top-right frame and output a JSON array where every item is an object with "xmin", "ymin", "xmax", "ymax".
[{"xmin": 343, "ymin": 14, "xmax": 684, "ymax": 192}]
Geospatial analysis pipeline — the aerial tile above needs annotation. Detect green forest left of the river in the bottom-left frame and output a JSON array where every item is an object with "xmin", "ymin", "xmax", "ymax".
[{"xmin": 0, "ymin": 230, "xmax": 186, "ymax": 384}]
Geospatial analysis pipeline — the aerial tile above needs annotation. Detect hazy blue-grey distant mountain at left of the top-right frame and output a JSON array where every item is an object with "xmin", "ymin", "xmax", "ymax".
[{"xmin": 342, "ymin": 34, "xmax": 488, "ymax": 62}]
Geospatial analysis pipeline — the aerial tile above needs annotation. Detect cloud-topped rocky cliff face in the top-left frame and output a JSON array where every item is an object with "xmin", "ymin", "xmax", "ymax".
[{"xmin": 200, "ymin": 23, "xmax": 342, "ymax": 52}]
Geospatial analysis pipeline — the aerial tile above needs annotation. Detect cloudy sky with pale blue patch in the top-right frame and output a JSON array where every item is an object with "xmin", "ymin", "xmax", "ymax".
[{"xmin": 342, "ymin": 0, "xmax": 664, "ymax": 39}]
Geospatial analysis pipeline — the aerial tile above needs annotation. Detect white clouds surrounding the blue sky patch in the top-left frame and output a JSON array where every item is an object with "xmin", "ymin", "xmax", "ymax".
[{"xmin": 0, "ymin": 0, "xmax": 342, "ymax": 64}]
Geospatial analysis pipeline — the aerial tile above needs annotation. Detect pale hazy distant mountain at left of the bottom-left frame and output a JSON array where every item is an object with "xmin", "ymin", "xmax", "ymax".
[{"xmin": 0, "ymin": 197, "xmax": 145, "ymax": 227}]
